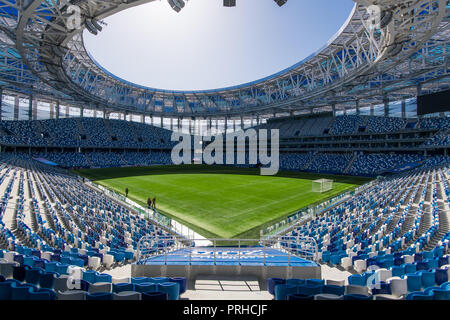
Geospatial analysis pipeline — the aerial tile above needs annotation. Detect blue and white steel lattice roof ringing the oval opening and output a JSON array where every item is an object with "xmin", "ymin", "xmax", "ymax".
[{"xmin": 0, "ymin": 0, "xmax": 450, "ymax": 117}]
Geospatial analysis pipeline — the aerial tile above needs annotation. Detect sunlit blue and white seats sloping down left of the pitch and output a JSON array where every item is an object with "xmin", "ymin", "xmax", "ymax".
[{"xmin": 0, "ymin": 157, "xmax": 183, "ymax": 290}]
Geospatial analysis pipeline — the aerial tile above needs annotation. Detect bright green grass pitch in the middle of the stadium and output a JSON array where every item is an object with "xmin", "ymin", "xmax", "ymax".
[{"xmin": 76, "ymin": 165, "xmax": 368, "ymax": 239}]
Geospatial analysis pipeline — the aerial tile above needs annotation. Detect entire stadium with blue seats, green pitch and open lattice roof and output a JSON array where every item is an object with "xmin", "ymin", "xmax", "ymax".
[{"xmin": 0, "ymin": 0, "xmax": 450, "ymax": 301}]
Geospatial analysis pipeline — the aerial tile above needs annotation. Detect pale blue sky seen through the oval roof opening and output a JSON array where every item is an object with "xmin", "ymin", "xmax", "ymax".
[{"xmin": 85, "ymin": 0, "xmax": 354, "ymax": 90}]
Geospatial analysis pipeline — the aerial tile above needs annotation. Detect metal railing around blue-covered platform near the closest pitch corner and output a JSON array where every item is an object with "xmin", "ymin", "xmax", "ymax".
[{"xmin": 137, "ymin": 236, "xmax": 318, "ymax": 266}]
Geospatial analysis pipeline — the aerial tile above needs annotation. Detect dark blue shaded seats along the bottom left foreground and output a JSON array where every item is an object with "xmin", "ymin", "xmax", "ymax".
[{"xmin": 0, "ymin": 259, "xmax": 186, "ymax": 300}]
